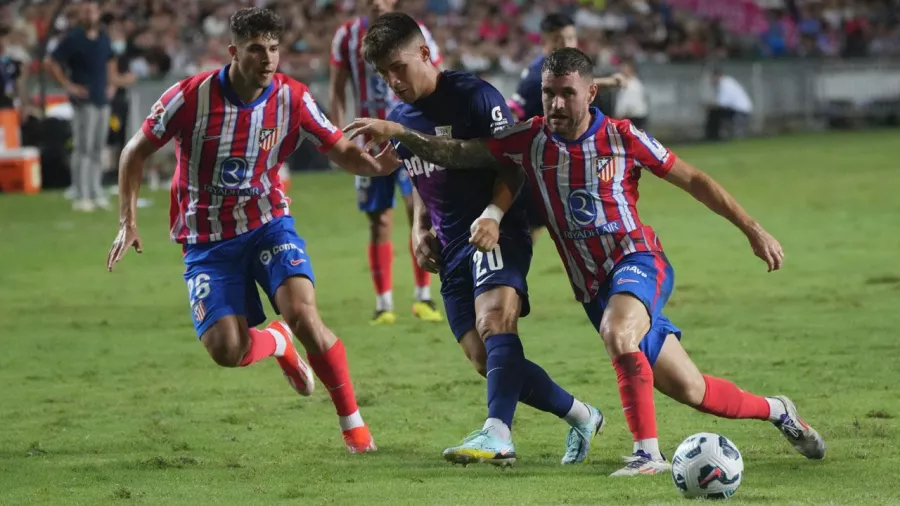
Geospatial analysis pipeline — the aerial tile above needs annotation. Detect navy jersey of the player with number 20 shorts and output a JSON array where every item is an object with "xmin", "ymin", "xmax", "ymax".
[{"xmin": 387, "ymin": 71, "xmax": 528, "ymax": 269}]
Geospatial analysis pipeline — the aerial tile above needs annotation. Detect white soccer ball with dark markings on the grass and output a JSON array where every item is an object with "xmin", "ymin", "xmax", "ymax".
[{"xmin": 672, "ymin": 432, "xmax": 744, "ymax": 499}]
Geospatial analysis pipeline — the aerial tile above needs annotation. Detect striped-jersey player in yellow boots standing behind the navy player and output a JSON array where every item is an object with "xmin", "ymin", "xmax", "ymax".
[{"xmin": 329, "ymin": 0, "xmax": 442, "ymax": 324}]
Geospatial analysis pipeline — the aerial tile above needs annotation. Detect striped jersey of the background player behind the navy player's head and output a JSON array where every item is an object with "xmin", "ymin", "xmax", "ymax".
[{"xmin": 331, "ymin": 16, "xmax": 443, "ymax": 140}]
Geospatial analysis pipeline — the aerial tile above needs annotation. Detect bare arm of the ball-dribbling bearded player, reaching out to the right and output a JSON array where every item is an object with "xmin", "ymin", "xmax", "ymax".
[{"xmin": 665, "ymin": 159, "xmax": 784, "ymax": 272}]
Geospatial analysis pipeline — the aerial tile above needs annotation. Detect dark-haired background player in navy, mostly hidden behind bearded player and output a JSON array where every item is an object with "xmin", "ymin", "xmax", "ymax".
[{"xmin": 506, "ymin": 12, "xmax": 625, "ymax": 245}]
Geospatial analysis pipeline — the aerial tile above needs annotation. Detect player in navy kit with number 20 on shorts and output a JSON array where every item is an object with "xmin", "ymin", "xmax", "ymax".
[{"xmin": 363, "ymin": 13, "xmax": 603, "ymax": 466}]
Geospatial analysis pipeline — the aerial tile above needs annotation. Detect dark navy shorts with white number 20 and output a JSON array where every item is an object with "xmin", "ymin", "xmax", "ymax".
[{"xmin": 441, "ymin": 236, "xmax": 531, "ymax": 341}]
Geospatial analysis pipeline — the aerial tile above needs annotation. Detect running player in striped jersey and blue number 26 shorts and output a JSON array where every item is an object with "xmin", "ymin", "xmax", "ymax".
[{"xmin": 107, "ymin": 9, "xmax": 399, "ymax": 453}]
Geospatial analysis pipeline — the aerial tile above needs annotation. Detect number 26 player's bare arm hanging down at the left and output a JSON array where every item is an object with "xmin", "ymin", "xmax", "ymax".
[{"xmin": 106, "ymin": 130, "xmax": 159, "ymax": 272}]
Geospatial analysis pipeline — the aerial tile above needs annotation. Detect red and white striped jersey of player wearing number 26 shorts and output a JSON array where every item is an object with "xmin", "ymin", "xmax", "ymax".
[{"xmin": 142, "ymin": 66, "xmax": 343, "ymax": 244}]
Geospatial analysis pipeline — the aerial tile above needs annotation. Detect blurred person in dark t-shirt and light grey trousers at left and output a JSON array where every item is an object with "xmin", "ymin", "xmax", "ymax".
[{"xmin": 47, "ymin": 1, "xmax": 119, "ymax": 211}]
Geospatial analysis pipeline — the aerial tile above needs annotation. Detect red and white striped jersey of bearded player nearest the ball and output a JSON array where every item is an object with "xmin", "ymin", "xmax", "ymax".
[{"xmin": 488, "ymin": 108, "xmax": 675, "ymax": 302}]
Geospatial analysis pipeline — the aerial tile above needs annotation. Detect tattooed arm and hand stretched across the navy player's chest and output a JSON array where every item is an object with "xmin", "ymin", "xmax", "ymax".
[{"xmin": 344, "ymin": 118, "xmax": 500, "ymax": 170}]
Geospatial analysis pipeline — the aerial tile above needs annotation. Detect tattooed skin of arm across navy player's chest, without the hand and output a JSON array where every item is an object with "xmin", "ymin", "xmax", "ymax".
[{"xmin": 397, "ymin": 128, "xmax": 500, "ymax": 170}]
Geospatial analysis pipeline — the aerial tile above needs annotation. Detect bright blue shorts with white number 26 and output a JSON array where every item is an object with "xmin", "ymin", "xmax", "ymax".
[{"xmin": 184, "ymin": 216, "xmax": 315, "ymax": 337}]
